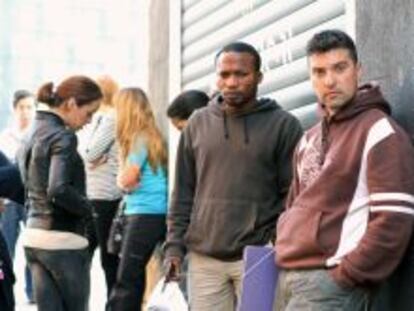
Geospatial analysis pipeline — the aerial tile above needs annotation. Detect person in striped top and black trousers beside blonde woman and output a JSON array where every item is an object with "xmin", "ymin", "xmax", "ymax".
[{"xmin": 81, "ymin": 76, "xmax": 122, "ymax": 296}]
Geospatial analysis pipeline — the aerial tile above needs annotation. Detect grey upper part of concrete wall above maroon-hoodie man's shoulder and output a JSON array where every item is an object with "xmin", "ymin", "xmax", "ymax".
[{"xmin": 355, "ymin": 0, "xmax": 414, "ymax": 138}]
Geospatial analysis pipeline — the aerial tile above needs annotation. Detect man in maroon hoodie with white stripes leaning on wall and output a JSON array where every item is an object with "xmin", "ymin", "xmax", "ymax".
[{"xmin": 275, "ymin": 30, "xmax": 414, "ymax": 311}]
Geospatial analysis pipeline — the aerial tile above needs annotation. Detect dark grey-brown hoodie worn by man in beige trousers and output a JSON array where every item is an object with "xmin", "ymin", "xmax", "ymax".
[{"xmin": 166, "ymin": 99, "xmax": 302, "ymax": 260}]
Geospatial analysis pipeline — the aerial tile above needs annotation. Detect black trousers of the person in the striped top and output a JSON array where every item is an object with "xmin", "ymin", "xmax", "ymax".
[{"xmin": 87, "ymin": 200, "xmax": 120, "ymax": 297}]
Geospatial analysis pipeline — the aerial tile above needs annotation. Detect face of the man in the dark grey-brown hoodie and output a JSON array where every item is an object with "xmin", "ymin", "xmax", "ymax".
[{"xmin": 216, "ymin": 52, "xmax": 262, "ymax": 109}]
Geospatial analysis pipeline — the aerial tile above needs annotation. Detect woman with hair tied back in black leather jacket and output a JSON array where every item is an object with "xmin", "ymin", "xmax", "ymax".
[{"xmin": 19, "ymin": 76, "xmax": 102, "ymax": 311}]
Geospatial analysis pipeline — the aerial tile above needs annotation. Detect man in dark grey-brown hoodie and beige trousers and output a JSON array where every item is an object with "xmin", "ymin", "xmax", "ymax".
[{"xmin": 165, "ymin": 42, "xmax": 302, "ymax": 311}]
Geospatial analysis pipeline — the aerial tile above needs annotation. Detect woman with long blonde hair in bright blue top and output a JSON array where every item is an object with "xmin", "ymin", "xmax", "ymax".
[{"xmin": 108, "ymin": 88, "xmax": 167, "ymax": 311}]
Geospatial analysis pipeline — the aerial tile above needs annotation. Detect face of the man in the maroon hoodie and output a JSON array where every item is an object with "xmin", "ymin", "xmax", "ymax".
[{"xmin": 309, "ymin": 48, "xmax": 360, "ymax": 115}]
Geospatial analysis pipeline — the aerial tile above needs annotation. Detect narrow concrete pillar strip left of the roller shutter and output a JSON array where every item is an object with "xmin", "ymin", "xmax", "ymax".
[{"xmin": 148, "ymin": 0, "xmax": 169, "ymax": 137}]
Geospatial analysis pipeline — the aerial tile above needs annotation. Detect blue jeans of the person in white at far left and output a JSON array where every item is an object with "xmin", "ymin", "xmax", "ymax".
[{"xmin": 1, "ymin": 201, "xmax": 33, "ymax": 301}]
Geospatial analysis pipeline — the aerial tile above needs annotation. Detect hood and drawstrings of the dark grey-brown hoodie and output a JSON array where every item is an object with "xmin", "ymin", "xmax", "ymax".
[{"xmin": 209, "ymin": 95, "xmax": 281, "ymax": 144}]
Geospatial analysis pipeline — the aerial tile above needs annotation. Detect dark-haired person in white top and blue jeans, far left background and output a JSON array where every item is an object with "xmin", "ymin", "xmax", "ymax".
[{"xmin": 0, "ymin": 90, "xmax": 36, "ymax": 303}]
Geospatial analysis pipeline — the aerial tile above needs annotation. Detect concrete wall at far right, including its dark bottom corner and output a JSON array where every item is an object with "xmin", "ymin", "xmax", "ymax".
[{"xmin": 355, "ymin": 0, "xmax": 414, "ymax": 311}]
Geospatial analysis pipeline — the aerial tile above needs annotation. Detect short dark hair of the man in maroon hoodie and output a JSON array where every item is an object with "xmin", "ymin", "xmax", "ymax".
[{"xmin": 306, "ymin": 29, "xmax": 358, "ymax": 63}]
